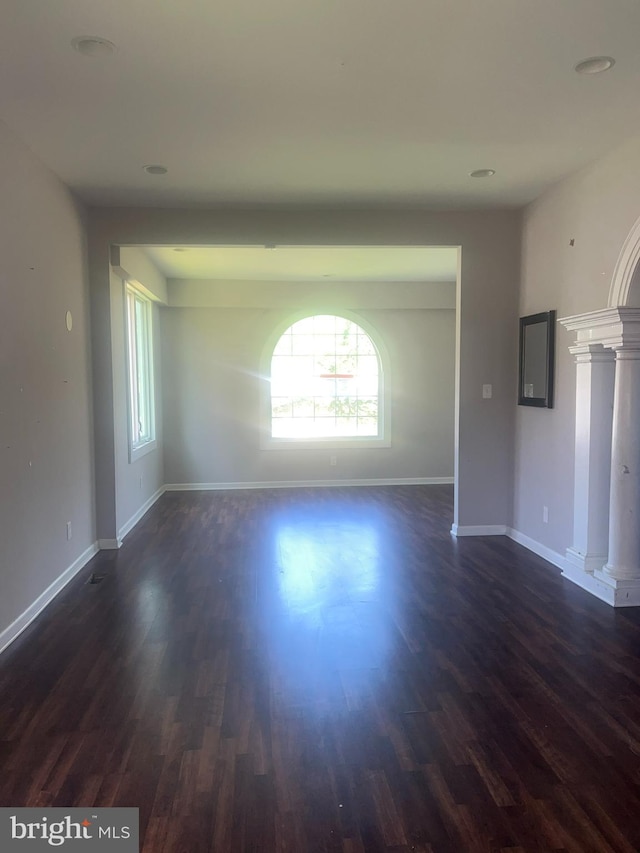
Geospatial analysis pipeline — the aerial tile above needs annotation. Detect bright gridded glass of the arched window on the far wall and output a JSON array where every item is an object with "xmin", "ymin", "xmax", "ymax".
[{"xmin": 271, "ymin": 314, "xmax": 383, "ymax": 441}]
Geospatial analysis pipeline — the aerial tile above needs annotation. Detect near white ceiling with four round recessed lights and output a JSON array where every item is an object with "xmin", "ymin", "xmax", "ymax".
[{"xmin": 0, "ymin": 0, "xmax": 640, "ymax": 207}]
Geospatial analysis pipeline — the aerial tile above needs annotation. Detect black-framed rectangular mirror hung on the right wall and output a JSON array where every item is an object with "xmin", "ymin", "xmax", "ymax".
[{"xmin": 518, "ymin": 311, "xmax": 556, "ymax": 409}]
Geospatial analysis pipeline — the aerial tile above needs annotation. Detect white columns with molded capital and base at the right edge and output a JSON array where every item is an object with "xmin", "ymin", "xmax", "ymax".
[{"xmin": 560, "ymin": 307, "xmax": 640, "ymax": 607}]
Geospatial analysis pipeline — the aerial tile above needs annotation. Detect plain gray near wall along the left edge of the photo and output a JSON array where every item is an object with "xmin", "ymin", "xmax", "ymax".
[{"xmin": 0, "ymin": 118, "xmax": 95, "ymax": 646}]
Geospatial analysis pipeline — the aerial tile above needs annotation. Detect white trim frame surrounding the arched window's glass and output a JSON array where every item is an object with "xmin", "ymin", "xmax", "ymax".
[{"xmin": 260, "ymin": 308, "xmax": 391, "ymax": 450}]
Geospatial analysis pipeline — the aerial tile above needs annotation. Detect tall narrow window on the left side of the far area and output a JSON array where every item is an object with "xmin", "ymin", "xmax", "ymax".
[{"xmin": 126, "ymin": 284, "xmax": 155, "ymax": 457}]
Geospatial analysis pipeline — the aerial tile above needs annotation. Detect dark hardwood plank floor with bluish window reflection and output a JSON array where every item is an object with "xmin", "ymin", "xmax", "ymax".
[{"xmin": 0, "ymin": 486, "xmax": 640, "ymax": 853}]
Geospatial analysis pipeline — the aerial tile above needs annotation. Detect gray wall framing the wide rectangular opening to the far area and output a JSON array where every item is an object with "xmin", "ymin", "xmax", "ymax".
[{"xmin": 89, "ymin": 208, "xmax": 520, "ymax": 524}]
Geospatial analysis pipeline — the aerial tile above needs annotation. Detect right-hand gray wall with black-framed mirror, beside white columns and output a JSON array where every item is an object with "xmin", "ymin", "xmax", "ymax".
[{"xmin": 513, "ymin": 139, "xmax": 640, "ymax": 555}]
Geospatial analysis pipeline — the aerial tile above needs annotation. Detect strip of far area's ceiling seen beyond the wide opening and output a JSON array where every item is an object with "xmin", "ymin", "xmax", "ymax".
[{"xmin": 146, "ymin": 246, "xmax": 458, "ymax": 282}]
